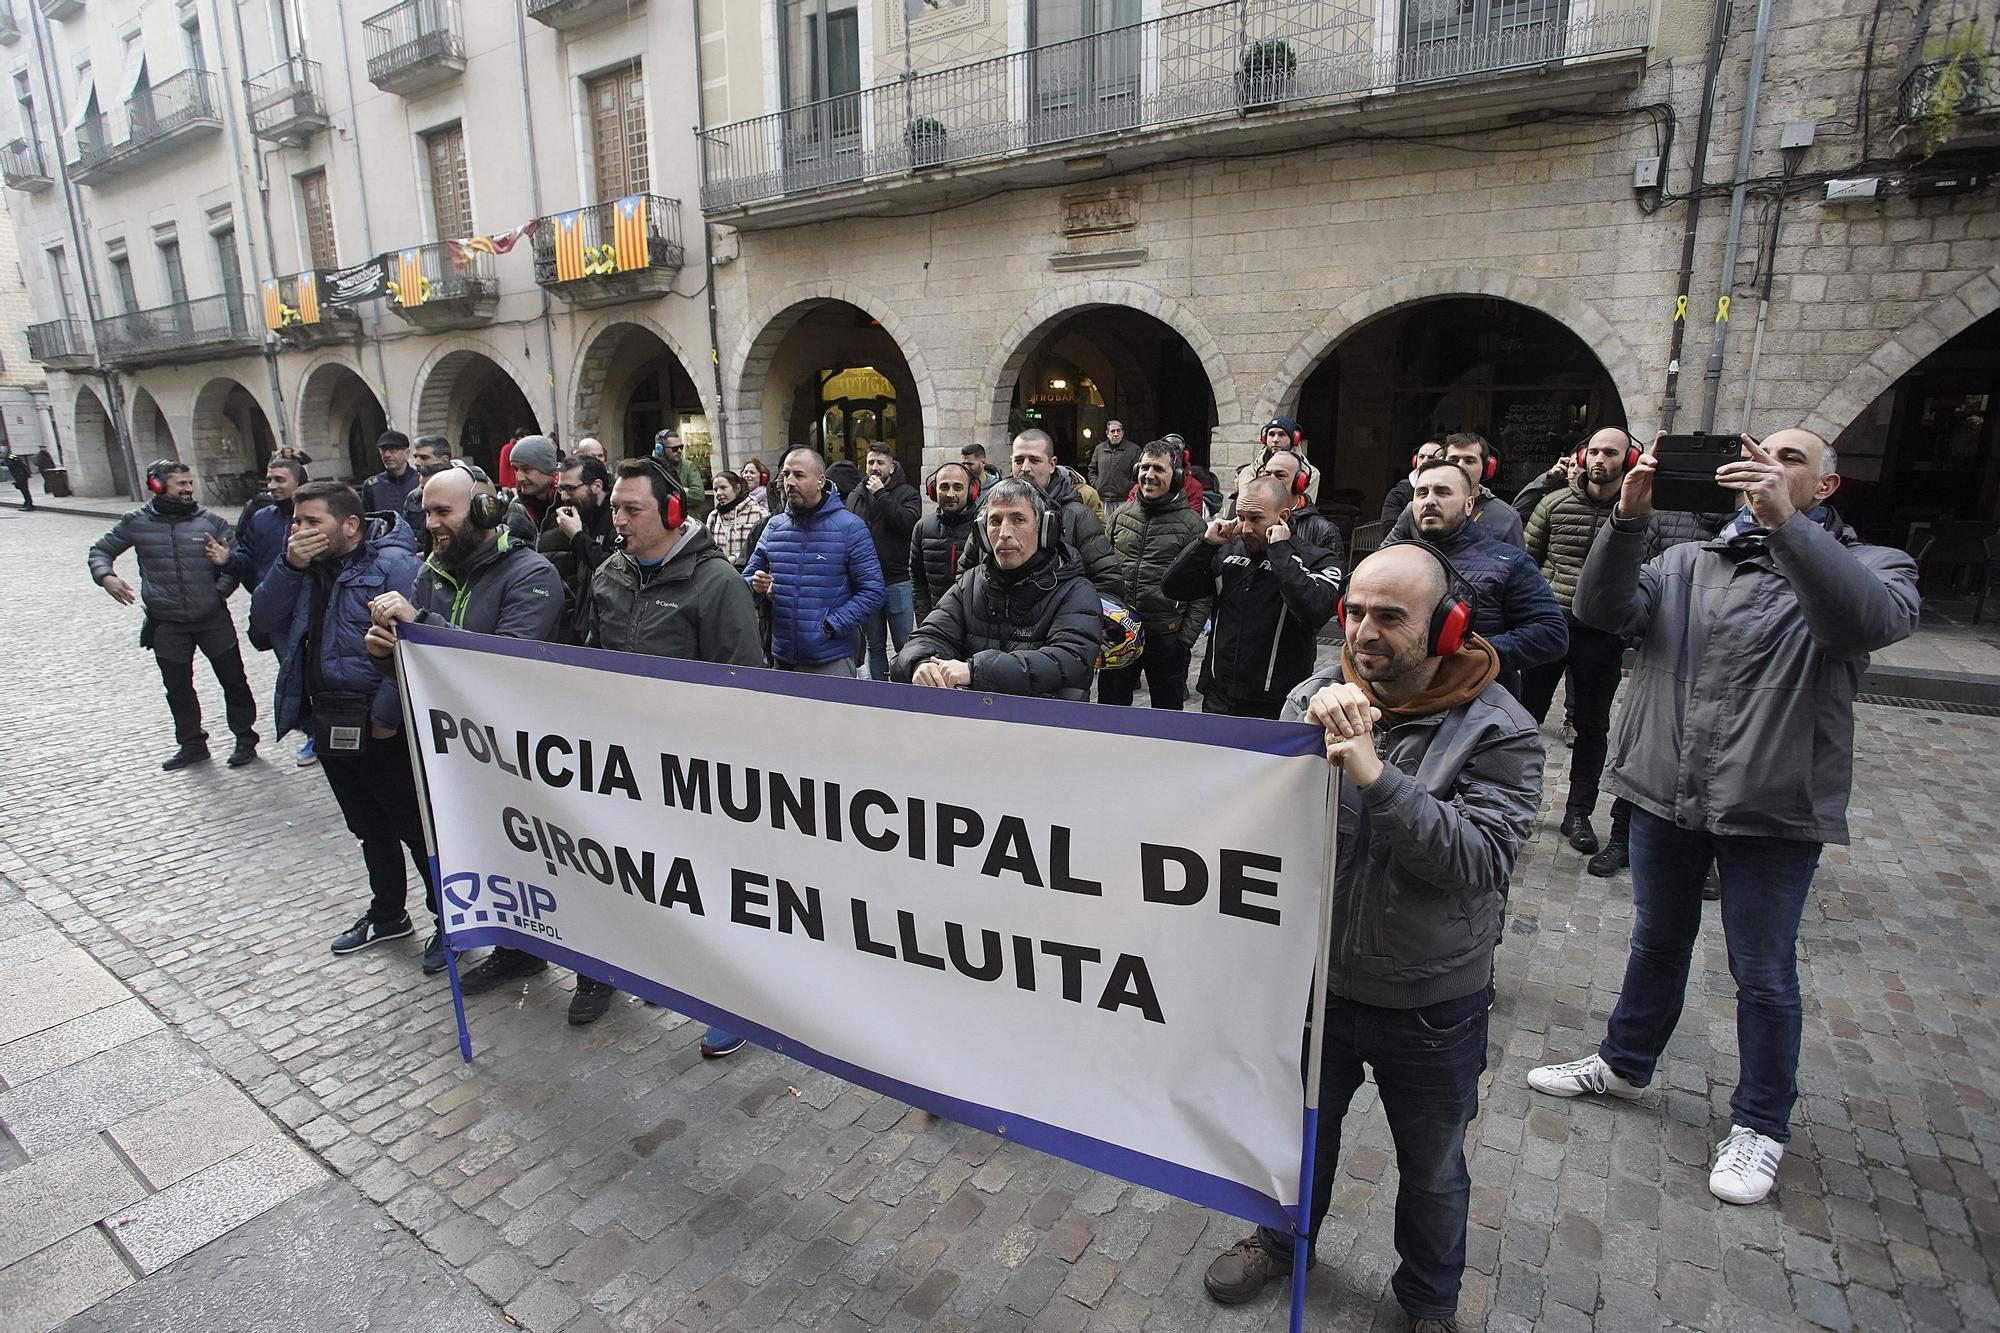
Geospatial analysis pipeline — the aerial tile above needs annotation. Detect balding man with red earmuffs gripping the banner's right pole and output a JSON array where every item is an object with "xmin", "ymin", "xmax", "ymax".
[{"xmin": 1204, "ymin": 542, "xmax": 1542, "ymax": 1333}]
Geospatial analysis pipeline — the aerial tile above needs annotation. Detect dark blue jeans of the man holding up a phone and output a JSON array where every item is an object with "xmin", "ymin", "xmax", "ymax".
[{"xmin": 1598, "ymin": 809, "xmax": 1820, "ymax": 1143}]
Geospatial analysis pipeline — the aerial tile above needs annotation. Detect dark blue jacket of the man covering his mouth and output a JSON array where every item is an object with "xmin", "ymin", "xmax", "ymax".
[{"xmin": 250, "ymin": 514, "xmax": 420, "ymax": 737}]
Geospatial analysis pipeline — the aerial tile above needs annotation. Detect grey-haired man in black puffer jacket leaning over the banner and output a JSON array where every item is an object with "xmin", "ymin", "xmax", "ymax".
[{"xmin": 894, "ymin": 476, "xmax": 1104, "ymax": 699}]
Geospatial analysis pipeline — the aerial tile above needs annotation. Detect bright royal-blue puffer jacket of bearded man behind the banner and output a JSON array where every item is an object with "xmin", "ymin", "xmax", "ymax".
[{"xmin": 744, "ymin": 486, "xmax": 884, "ymax": 667}]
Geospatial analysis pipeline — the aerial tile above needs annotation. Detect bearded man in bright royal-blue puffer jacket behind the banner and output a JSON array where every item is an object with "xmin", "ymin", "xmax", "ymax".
[{"xmin": 744, "ymin": 448, "xmax": 882, "ymax": 677}]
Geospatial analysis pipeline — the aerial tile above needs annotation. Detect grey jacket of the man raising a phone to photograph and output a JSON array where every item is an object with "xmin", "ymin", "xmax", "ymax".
[{"xmin": 1572, "ymin": 510, "xmax": 1918, "ymax": 843}]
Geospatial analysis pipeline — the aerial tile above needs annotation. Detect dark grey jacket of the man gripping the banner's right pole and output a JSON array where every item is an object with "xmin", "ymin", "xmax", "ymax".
[{"xmin": 1282, "ymin": 662, "xmax": 1542, "ymax": 1009}]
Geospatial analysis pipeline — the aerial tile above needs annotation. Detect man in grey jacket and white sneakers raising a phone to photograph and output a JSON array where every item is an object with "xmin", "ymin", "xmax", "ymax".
[{"xmin": 1528, "ymin": 430, "xmax": 1918, "ymax": 1203}]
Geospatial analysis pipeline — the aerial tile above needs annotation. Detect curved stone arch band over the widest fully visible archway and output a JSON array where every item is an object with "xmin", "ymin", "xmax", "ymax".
[{"xmin": 1252, "ymin": 268, "xmax": 1652, "ymax": 432}]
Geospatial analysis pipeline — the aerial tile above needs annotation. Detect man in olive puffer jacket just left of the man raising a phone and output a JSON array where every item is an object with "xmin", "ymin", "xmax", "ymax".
[{"xmin": 1520, "ymin": 426, "xmax": 1638, "ymax": 855}]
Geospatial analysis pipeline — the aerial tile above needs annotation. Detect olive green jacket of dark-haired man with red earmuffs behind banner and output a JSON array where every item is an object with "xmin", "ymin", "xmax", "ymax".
[{"xmin": 584, "ymin": 522, "xmax": 764, "ymax": 667}]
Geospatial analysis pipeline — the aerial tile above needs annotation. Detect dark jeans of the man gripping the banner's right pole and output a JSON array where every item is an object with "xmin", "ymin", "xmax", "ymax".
[{"xmin": 1258, "ymin": 987, "xmax": 1492, "ymax": 1319}]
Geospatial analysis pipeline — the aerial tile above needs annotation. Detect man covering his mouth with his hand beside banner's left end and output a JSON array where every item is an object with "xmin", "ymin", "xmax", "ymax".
[{"xmin": 250, "ymin": 482, "xmax": 426, "ymax": 971}]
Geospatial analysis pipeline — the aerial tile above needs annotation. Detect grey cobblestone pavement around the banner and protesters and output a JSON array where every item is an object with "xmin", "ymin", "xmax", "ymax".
[{"xmin": 0, "ymin": 504, "xmax": 2000, "ymax": 1333}]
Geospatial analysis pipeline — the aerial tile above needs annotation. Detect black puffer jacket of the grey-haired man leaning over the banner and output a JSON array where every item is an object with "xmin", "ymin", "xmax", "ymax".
[{"xmin": 890, "ymin": 546, "xmax": 1104, "ymax": 701}]
